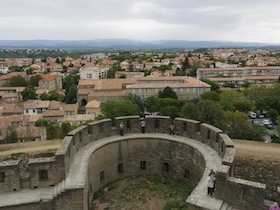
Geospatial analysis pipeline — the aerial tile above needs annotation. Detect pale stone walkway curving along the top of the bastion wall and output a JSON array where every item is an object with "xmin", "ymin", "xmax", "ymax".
[{"xmin": 0, "ymin": 133, "xmax": 222, "ymax": 209}]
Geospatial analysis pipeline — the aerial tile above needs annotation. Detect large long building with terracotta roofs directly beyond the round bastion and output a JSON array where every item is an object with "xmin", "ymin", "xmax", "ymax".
[{"xmin": 77, "ymin": 76, "xmax": 211, "ymax": 109}]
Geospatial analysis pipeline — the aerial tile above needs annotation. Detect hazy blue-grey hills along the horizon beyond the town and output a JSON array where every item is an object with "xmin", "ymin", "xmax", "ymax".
[{"xmin": 0, "ymin": 39, "xmax": 280, "ymax": 50}]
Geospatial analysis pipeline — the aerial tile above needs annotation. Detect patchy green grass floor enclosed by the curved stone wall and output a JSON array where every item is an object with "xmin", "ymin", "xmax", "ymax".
[{"xmin": 92, "ymin": 175, "xmax": 193, "ymax": 210}]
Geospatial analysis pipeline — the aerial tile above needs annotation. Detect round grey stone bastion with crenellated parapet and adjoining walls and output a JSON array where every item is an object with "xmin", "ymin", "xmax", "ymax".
[{"xmin": 0, "ymin": 115, "xmax": 274, "ymax": 210}]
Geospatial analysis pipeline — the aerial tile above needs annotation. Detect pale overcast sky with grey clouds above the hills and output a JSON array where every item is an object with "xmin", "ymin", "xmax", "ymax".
[{"xmin": 0, "ymin": 0, "xmax": 280, "ymax": 43}]
